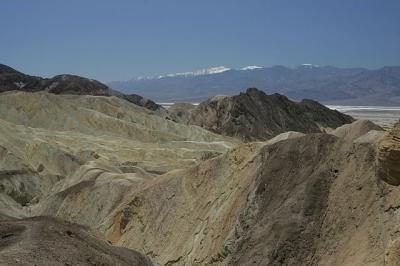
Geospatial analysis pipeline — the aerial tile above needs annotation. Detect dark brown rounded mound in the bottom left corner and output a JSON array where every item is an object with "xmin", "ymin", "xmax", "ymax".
[{"xmin": 0, "ymin": 216, "xmax": 154, "ymax": 266}]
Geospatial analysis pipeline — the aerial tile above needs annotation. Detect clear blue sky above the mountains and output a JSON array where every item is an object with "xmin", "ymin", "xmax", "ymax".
[{"xmin": 0, "ymin": 0, "xmax": 400, "ymax": 81}]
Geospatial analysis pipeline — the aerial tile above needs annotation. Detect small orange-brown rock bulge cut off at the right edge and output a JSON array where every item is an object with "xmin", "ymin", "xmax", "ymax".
[{"xmin": 378, "ymin": 122, "xmax": 400, "ymax": 186}]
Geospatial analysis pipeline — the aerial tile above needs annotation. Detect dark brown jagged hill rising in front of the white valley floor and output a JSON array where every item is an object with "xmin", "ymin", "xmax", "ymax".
[{"xmin": 187, "ymin": 88, "xmax": 353, "ymax": 141}]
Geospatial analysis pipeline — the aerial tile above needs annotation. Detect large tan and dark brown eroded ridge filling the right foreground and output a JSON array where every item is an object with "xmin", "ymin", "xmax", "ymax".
[{"xmin": 36, "ymin": 120, "xmax": 399, "ymax": 265}]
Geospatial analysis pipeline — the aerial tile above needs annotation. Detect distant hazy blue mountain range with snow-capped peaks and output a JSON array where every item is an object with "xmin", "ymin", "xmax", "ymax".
[{"xmin": 108, "ymin": 64, "xmax": 400, "ymax": 106}]
